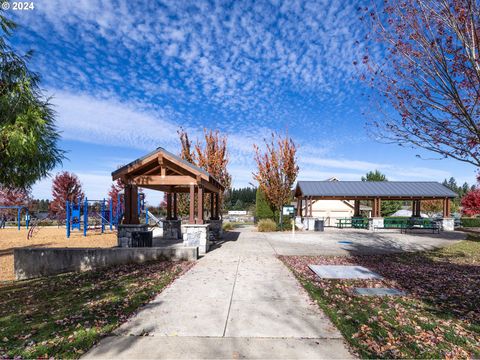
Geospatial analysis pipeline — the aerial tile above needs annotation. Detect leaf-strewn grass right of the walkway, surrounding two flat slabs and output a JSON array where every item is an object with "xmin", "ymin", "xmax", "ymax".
[{"xmin": 281, "ymin": 236, "xmax": 480, "ymax": 358}]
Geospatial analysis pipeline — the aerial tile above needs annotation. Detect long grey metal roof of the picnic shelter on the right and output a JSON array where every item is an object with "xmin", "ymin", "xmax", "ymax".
[{"xmin": 295, "ymin": 181, "xmax": 457, "ymax": 198}]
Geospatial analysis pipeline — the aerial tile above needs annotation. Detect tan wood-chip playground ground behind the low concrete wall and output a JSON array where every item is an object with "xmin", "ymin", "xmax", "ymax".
[{"xmin": 0, "ymin": 226, "xmax": 117, "ymax": 282}]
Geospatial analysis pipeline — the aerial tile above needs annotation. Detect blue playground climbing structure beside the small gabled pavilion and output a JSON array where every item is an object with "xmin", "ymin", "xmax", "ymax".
[{"xmin": 65, "ymin": 193, "xmax": 148, "ymax": 238}]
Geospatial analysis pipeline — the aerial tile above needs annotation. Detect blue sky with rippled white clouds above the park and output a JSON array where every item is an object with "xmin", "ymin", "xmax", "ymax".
[{"xmin": 9, "ymin": 0, "xmax": 475, "ymax": 203}]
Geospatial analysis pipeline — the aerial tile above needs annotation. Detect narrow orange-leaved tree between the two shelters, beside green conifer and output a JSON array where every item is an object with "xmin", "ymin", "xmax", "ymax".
[{"xmin": 253, "ymin": 133, "xmax": 299, "ymax": 222}]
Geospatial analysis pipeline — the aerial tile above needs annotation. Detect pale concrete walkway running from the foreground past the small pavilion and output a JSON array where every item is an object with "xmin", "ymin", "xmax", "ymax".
[{"xmin": 85, "ymin": 229, "xmax": 352, "ymax": 359}]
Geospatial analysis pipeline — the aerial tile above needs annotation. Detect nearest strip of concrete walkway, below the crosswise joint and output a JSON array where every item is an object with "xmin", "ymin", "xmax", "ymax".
[{"xmin": 83, "ymin": 336, "xmax": 354, "ymax": 360}]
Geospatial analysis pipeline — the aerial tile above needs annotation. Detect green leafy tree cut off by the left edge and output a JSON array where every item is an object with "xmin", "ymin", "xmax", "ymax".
[{"xmin": 0, "ymin": 10, "xmax": 63, "ymax": 189}]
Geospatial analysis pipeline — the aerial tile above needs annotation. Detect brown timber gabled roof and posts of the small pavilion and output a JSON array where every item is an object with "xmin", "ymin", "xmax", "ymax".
[{"xmin": 112, "ymin": 147, "xmax": 225, "ymax": 224}]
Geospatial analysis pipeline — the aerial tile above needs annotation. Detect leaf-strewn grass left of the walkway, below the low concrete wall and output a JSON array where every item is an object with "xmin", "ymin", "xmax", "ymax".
[{"xmin": 0, "ymin": 261, "xmax": 192, "ymax": 358}]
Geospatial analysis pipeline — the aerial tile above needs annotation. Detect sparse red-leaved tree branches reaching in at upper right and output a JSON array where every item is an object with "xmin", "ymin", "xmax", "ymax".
[{"xmin": 362, "ymin": 0, "xmax": 480, "ymax": 166}]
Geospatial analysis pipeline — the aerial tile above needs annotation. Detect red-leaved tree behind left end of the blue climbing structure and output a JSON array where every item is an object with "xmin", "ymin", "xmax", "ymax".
[{"xmin": 50, "ymin": 171, "xmax": 84, "ymax": 219}]
